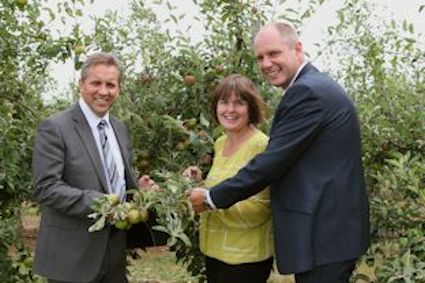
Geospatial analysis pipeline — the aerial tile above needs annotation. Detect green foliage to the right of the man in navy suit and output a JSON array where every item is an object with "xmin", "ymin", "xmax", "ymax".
[{"xmin": 325, "ymin": 0, "xmax": 425, "ymax": 282}]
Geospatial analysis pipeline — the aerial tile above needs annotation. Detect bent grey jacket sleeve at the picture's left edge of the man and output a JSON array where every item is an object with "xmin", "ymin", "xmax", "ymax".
[{"xmin": 32, "ymin": 120, "xmax": 102, "ymax": 218}]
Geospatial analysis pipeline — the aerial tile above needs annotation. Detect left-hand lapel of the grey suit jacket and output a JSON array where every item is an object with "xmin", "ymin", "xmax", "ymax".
[{"xmin": 73, "ymin": 104, "xmax": 107, "ymax": 192}]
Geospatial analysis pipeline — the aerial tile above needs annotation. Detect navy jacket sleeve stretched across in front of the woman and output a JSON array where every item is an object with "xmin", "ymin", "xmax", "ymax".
[{"xmin": 210, "ymin": 85, "xmax": 324, "ymax": 208}]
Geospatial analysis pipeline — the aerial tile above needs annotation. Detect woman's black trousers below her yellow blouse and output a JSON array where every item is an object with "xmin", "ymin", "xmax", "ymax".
[{"xmin": 205, "ymin": 257, "xmax": 273, "ymax": 283}]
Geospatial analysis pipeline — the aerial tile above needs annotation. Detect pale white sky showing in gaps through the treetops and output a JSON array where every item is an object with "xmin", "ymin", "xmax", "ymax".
[{"xmin": 44, "ymin": 0, "xmax": 425, "ymax": 100}]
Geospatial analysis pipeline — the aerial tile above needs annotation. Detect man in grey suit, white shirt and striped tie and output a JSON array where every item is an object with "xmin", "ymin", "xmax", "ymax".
[{"xmin": 33, "ymin": 53, "xmax": 147, "ymax": 283}]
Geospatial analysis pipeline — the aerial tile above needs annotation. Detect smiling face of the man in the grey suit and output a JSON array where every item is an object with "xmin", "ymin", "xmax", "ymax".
[{"xmin": 80, "ymin": 64, "xmax": 120, "ymax": 117}]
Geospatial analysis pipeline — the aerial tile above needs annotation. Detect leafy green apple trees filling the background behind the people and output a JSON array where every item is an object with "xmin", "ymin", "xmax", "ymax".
[{"xmin": 0, "ymin": 0, "xmax": 425, "ymax": 282}]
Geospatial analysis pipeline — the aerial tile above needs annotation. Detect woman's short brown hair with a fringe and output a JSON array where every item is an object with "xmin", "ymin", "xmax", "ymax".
[{"xmin": 211, "ymin": 74, "xmax": 266, "ymax": 125}]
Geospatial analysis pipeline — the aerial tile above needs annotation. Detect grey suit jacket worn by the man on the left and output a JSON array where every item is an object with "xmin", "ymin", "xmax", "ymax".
[{"xmin": 33, "ymin": 104, "xmax": 136, "ymax": 282}]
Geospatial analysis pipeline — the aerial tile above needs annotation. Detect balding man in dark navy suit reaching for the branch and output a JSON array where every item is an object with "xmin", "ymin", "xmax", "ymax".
[{"xmin": 189, "ymin": 23, "xmax": 369, "ymax": 283}]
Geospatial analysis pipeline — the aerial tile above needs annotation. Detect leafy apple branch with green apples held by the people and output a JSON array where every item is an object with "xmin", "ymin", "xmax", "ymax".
[{"xmin": 88, "ymin": 171, "xmax": 198, "ymax": 247}]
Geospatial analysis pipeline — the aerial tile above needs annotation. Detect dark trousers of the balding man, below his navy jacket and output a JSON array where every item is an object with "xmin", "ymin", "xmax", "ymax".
[{"xmin": 295, "ymin": 260, "xmax": 356, "ymax": 283}]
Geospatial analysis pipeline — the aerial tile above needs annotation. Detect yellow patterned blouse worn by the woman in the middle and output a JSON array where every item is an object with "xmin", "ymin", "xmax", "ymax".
[{"xmin": 199, "ymin": 129, "xmax": 274, "ymax": 264}]
